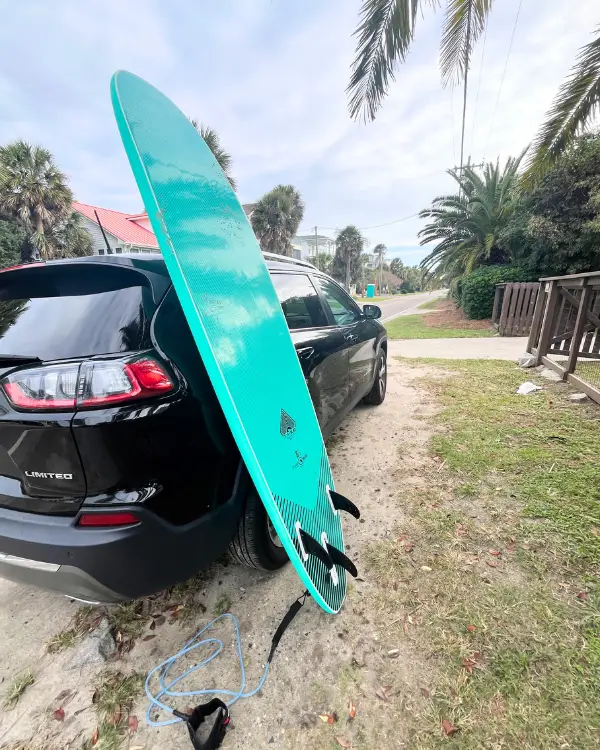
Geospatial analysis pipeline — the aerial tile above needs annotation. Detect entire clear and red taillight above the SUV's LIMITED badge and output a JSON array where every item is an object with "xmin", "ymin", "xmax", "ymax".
[{"xmin": 0, "ymin": 357, "xmax": 173, "ymax": 411}]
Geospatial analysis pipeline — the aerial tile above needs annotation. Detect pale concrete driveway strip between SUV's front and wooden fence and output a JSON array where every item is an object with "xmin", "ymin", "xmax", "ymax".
[{"xmin": 389, "ymin": 336, "xmax": 527, "ymax": 361}]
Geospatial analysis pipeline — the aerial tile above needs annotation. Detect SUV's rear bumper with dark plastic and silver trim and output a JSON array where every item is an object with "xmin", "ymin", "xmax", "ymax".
[{"xmin": 0, "ymin": 493, "xmax": 241, "ymax": 603}]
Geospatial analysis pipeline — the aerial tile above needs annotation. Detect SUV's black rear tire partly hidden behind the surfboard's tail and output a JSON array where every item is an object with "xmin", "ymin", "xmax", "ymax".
[{"xmin": 229, "ymin": 486, "xmax": 289, "ymax": 570}]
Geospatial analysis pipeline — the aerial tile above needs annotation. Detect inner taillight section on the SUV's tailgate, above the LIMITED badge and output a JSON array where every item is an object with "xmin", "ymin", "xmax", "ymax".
[{"xmin": 2, "ymin": 364, "xmax": 79, "ymax": 411}]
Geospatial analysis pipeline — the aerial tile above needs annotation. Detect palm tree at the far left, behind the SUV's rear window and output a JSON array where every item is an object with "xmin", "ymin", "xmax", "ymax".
[{"xmin": 0, "ymin": 141, "xmax": 73, "ymax": 258}]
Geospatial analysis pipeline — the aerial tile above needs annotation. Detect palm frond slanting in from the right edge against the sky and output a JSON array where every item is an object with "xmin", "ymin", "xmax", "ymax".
[{"xmin": 522, "ymin": 26, "xmax": 600, "ymax": 189}]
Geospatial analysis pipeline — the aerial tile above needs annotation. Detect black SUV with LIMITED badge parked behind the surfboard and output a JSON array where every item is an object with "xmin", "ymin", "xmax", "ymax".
[{"xmin": 0, "ymin": 254, "xmax": 387, "ymax": 602}]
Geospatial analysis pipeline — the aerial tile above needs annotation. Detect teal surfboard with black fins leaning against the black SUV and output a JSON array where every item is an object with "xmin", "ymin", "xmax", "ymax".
[{"xmin": 111, "ymin": 71, "xmax": 356, "ymax": 613}]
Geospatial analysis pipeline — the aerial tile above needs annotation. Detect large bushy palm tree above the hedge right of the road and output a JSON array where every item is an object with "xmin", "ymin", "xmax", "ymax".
[{"xmin": 419, "ymin": 154, "xmax": 523, "ymax": 284}]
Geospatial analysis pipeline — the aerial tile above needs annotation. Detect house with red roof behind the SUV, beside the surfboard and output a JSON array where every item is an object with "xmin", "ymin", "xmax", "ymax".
[{"xmin": 73, "ymin": 201, "xmax": 255, "ymax": 255}]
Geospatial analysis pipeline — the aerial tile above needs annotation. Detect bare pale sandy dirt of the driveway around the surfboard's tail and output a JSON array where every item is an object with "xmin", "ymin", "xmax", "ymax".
[{"xmin": 0, "ymin": 360, "xmax": 440, "ymax": 750}]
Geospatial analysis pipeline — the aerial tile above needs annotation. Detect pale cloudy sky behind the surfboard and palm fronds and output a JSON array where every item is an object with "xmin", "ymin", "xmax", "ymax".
[{"xmin": 0, "ymin": 0, "xmax": 600, "ymax": 265}]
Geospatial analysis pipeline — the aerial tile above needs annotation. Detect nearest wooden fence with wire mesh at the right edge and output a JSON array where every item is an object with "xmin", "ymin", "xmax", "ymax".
[{"xmin": 527, "ymin": 271, "xmax": 600, "ymax": 403}]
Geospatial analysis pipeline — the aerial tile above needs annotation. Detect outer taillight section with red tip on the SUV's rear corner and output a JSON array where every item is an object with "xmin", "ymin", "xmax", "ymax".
[{"xmin": 79, "ymin": 358, "xmax": 173, "ymax": 406}]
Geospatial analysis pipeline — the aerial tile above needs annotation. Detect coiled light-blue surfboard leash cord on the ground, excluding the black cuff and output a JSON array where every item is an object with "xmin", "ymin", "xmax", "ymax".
[{"xmin": 144, "ymin": 591, "xmax": 309, "ymax": 727}]
